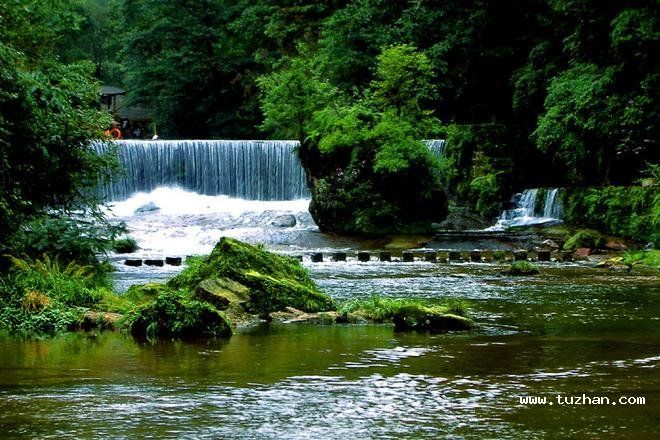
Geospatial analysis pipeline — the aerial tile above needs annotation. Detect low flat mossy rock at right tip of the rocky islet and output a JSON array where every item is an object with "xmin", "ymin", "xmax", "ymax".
[{"xmin": 392, "ymin": 305, "xmax": 474, "ymax": 332}]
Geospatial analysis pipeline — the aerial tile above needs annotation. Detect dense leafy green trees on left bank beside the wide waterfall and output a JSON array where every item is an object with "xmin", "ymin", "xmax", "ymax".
[{"xmin": 0, "ymin": 0, "xmax": 113, "ymax": 263}]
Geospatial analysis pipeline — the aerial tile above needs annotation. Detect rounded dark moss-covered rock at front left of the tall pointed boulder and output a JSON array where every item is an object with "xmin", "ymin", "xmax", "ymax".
[{"xmin": 122, "ymin": 285, "xmax": 232, "ymax": 338}]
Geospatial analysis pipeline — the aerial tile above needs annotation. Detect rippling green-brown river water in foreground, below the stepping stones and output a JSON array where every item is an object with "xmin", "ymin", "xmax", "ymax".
[{"xmin": 0, "ymin": 262, "xmax": 660, "ymax": 439}]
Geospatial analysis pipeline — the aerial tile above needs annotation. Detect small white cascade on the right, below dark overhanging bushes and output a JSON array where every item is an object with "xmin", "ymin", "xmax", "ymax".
[{"xmin": 486, "ymin": 188, "xmax": 564, "ymax": 231}]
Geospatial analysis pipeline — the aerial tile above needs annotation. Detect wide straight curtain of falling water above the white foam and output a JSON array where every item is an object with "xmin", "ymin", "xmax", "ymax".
[{"xmin": 93, "ymin": 140, "xmax": 309, "ymax": 201}]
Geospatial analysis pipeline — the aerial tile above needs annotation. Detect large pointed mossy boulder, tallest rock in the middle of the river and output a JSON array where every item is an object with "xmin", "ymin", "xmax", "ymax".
[{"xmin": 168, "ymin": 237, "xmax": 334, "ymax": 317}]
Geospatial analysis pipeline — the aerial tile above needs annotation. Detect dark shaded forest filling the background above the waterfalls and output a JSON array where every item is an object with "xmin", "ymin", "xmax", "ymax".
[{"xmin": 0, "ymin": 0, "xmax": 660, "ymax": 237}]
